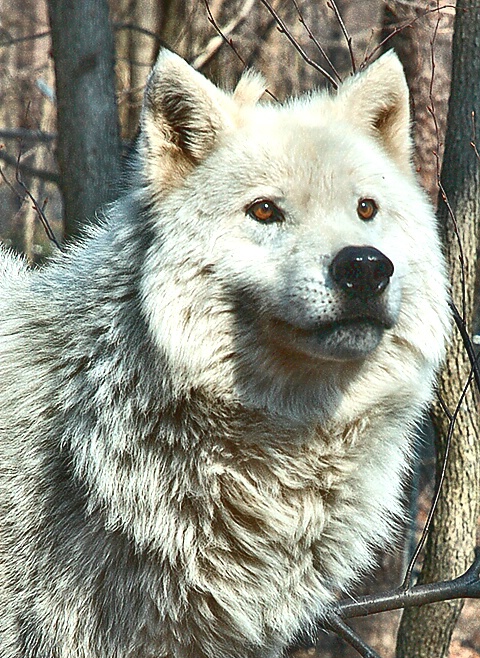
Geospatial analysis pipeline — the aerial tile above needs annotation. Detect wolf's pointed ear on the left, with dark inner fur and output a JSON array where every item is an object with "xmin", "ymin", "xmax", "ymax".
[{"xmin": 140, "ymin": 49, "xmax": 233, "ymax": 186}]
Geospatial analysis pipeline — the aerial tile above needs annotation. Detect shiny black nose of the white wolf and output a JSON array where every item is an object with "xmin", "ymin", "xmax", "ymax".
[{"xmin": 330, "ymin": 247, "xmax": 393, "ymax": 297}]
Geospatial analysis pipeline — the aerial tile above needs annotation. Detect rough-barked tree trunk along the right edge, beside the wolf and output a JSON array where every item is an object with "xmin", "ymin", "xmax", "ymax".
[{"xmin": 397, "ymin": 0, "xmax": 480, "ymax": 658}]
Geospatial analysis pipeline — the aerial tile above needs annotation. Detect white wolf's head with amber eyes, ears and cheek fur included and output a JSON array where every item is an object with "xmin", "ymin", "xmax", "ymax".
[{"xmin": 139, "ymin": 51, "xmax": 448, "ymax": 420}]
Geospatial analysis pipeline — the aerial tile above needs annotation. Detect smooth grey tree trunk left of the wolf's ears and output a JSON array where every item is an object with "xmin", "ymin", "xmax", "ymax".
[{"xmin": 48, "ymin": 0, "xmax": 120, "ymax": 238}]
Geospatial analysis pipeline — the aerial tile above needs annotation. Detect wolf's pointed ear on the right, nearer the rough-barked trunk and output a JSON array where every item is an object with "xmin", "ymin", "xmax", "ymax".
[{"xmin": 337, "ymin": 50, "xmax": 412, "ymax": 173}]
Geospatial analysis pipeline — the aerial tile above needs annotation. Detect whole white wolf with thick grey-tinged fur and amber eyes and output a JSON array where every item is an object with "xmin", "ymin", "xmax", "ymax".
[{"xmin": 0, "ymin": 50, "xmax": 449, "ymax": 658}]
